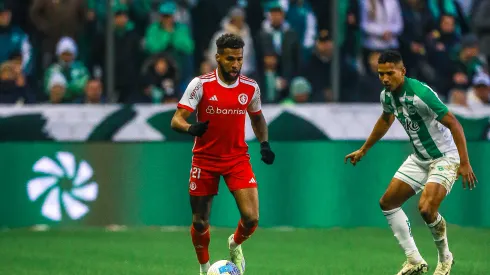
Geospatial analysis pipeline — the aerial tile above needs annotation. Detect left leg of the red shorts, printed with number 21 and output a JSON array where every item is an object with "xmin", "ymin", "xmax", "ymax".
[{"xmin": 189, "ymin": 166, "xmax": 220, "ymax": 196}]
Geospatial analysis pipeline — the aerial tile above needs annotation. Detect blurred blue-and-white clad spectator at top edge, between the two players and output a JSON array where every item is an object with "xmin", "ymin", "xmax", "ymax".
[{"xmin": 283, "ymin": 0, "xmax": 317, "ymax": 61}]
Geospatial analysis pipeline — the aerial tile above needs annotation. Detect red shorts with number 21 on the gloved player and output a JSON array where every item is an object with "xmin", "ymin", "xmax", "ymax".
[{"xmin": 189, "ymin": 161, "xmax": 257, "ymax": 196}]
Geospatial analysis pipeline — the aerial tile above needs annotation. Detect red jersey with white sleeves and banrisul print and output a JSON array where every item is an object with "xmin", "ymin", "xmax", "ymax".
[{"xmin": 178, "ymin": 70, "xmax": 261, "ymax": 165}]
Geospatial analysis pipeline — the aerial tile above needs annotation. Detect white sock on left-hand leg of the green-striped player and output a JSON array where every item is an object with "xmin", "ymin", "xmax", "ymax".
[{"xmin": 383, "ymin": 207, "xmax": 423, "ymax": 264}]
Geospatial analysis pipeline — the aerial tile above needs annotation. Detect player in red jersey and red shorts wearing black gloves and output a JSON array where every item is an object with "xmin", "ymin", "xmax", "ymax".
[{"xmin": 172, "ymin": 34, "xmax": 275, "ymax": 275}]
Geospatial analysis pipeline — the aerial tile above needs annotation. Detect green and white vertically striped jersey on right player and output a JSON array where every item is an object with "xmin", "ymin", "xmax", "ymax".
[{"xmin": 381, "ymin": 77, "xmax": 457, "ymax": 159}]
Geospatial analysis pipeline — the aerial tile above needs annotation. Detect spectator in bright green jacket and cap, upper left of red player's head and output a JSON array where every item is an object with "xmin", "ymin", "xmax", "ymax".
[{"xmin": 145, "ymin": 1, "xmax": 194, "ymax": 87}]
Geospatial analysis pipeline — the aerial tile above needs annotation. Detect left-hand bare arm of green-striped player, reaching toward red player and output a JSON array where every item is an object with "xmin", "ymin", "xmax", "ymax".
[{"xmin": 344, "ymin": 112, "xmax": 395, "ymax": 166}]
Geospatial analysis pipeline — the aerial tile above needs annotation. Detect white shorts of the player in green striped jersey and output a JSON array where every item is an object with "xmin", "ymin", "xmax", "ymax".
[{"xmin": 395, "ymin": 151, "xmax": 459, "ymax": 194}]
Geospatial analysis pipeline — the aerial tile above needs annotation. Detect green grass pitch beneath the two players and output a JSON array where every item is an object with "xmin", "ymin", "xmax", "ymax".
[{"xmin": 0, "ymin": 226, "xmax": 490, "ymax": 275}]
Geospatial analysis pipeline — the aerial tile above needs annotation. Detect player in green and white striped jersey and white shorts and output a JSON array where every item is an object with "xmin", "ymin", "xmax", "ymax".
[{"xmin": 344, "ymin": 51, "xmax": 477, "ymax": 275}]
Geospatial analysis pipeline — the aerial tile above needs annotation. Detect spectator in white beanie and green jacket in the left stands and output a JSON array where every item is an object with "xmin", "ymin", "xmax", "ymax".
[{"xmin": 45, "ymin": 37, "xmax": 89, "ymax": 101}]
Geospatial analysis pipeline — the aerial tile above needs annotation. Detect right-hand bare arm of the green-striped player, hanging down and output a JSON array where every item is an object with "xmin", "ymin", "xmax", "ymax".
[{"xmin": 441, "ymin": 112, "xmax": 477, "ymax": 190}]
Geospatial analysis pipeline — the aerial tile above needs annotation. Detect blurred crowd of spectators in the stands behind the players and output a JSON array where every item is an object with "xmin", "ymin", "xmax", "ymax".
[{"xmin": 0, "ymin": 0, "xmax": 490, "ymax": 107}]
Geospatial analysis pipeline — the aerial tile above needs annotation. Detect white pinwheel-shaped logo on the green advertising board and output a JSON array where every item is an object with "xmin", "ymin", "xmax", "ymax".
[{"xmin": 27, "ymin": 152, "xmax": 98, "ymax": 221}]
